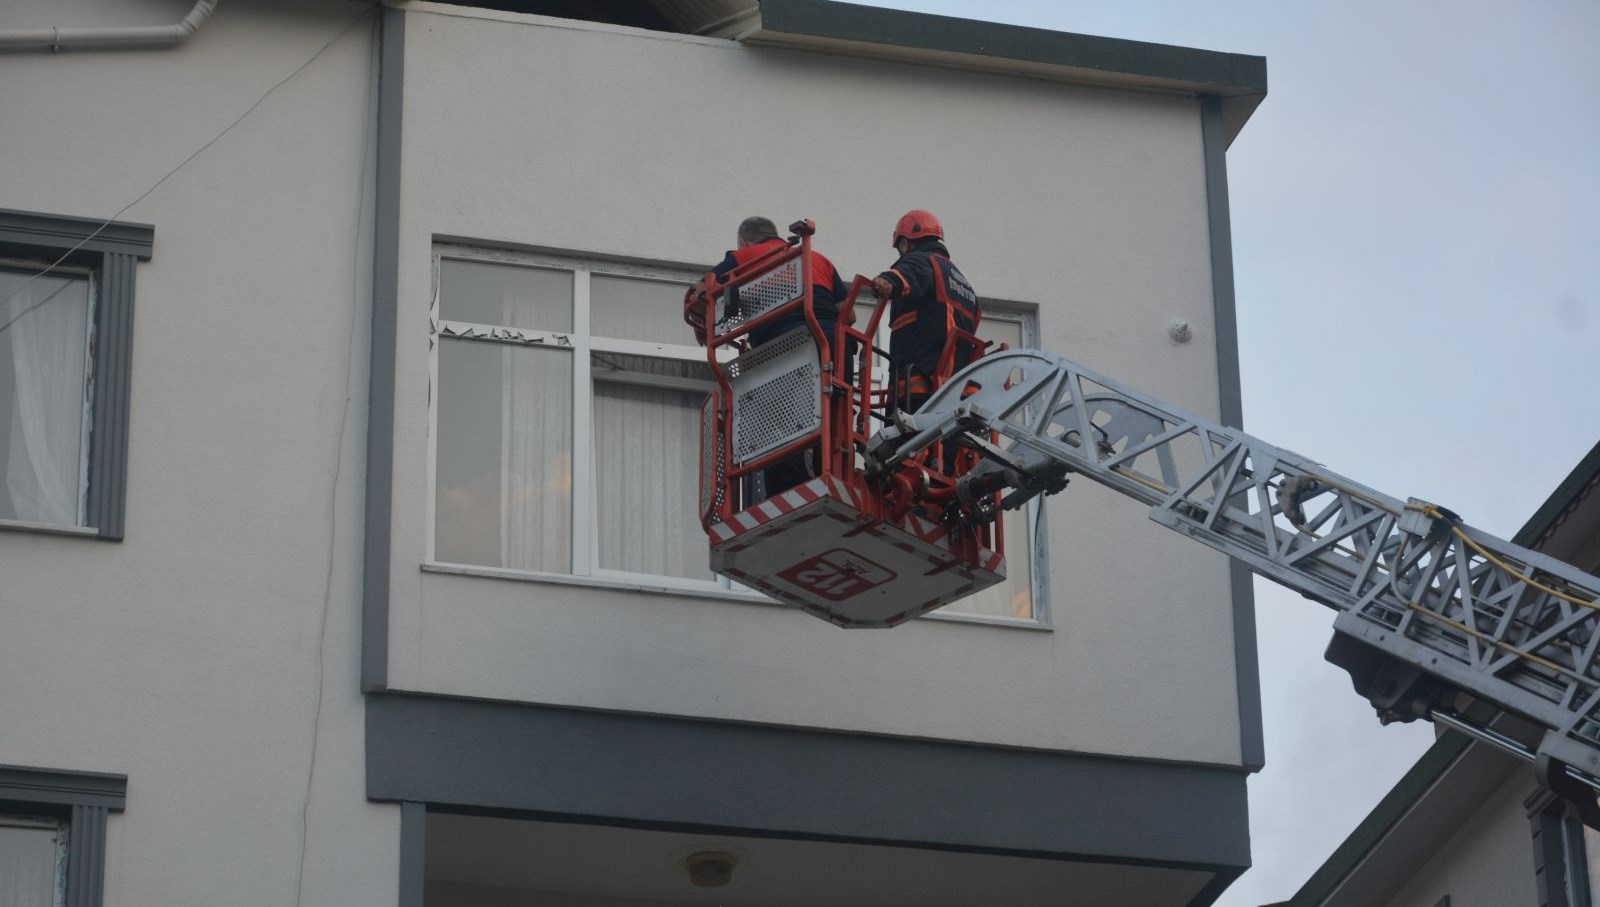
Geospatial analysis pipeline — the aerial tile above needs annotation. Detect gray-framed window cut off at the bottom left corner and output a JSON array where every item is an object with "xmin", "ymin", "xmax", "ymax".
[{"xmin": 0, "ymin": 766, "xmax": 128, "ymax": 907}]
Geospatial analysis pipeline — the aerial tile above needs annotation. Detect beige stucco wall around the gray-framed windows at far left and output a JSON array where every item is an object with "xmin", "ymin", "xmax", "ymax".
[{"xmin": 0, "ymin": 0, "xmax": 398, "ymax": 907}]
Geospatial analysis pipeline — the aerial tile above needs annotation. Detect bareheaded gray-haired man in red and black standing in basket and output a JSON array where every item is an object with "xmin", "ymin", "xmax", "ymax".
[{"xmin": 683, "ymin": 216, "xmax": 848, "ymax": 497}]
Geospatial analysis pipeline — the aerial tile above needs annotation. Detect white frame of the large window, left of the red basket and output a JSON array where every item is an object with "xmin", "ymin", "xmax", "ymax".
[{"xmin": 426, "ymin": 243, "xmax": 748, "ymax": 601}]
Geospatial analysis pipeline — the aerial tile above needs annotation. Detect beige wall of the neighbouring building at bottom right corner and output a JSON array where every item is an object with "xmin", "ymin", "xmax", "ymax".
[{"xmin": 1384, "ymin": 771, "xmax": 1539, "ymax": 907}]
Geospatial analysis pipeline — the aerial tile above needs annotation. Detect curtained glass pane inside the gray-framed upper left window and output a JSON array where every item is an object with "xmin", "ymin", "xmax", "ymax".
[{"xmin": 0, "ymin": 263, "xmax": 91, "ymax": 526}]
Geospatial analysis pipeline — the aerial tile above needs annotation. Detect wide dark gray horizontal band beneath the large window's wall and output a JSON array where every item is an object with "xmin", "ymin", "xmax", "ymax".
[{"xmin": 366, "ymin": 693, "xmax": 1250, "ymax": 872}]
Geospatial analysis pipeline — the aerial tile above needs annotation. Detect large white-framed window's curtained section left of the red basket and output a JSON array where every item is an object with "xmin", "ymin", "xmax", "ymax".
[{"xmin": 430, "ymin": 248, "xmax": 726, "ymax": 589}]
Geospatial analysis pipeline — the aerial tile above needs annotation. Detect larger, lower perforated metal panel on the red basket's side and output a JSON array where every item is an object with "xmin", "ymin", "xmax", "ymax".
[{"xmin": 728, "ymin": 328, "xmax": 822, "ymax": 464}]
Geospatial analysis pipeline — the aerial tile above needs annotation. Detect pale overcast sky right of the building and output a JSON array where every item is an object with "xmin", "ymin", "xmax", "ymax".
[{"xmin": 844, "ymin": 0, "xmax": 1600, "ymax": 907}]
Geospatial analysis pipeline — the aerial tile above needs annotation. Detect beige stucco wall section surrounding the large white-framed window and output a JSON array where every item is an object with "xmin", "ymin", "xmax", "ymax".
[{"xmin": 389, "ymin": 3, "xmax": 1240, "ymax": 765}]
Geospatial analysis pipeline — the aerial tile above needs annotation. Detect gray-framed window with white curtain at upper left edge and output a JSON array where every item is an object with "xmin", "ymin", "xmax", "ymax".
[{"xmin": 0, "ymin": 210, "xmax": 154, "ymax": 539}]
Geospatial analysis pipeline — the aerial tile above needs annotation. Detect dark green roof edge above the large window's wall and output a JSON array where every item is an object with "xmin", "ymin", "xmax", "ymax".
[{"xmin": 741, "ymin": 0, "xmax": 1267, "ymax": 141}]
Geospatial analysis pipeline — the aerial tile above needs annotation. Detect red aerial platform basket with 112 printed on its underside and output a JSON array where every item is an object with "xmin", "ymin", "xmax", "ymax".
[{"xmin": 694, "ymin": 221, "xmax": 1005, "ymax": 627}]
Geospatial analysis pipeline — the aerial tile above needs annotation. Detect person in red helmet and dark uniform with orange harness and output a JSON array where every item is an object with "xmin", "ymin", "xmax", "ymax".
[{"xmin": 872, "ymin": 208, "xmax": 982, "ymax": 411}]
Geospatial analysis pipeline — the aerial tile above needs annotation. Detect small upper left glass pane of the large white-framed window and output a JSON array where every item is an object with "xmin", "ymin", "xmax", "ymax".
[{"xmin": 438, "ymin": 258, "xmax": 573, "ymax": 331}]
